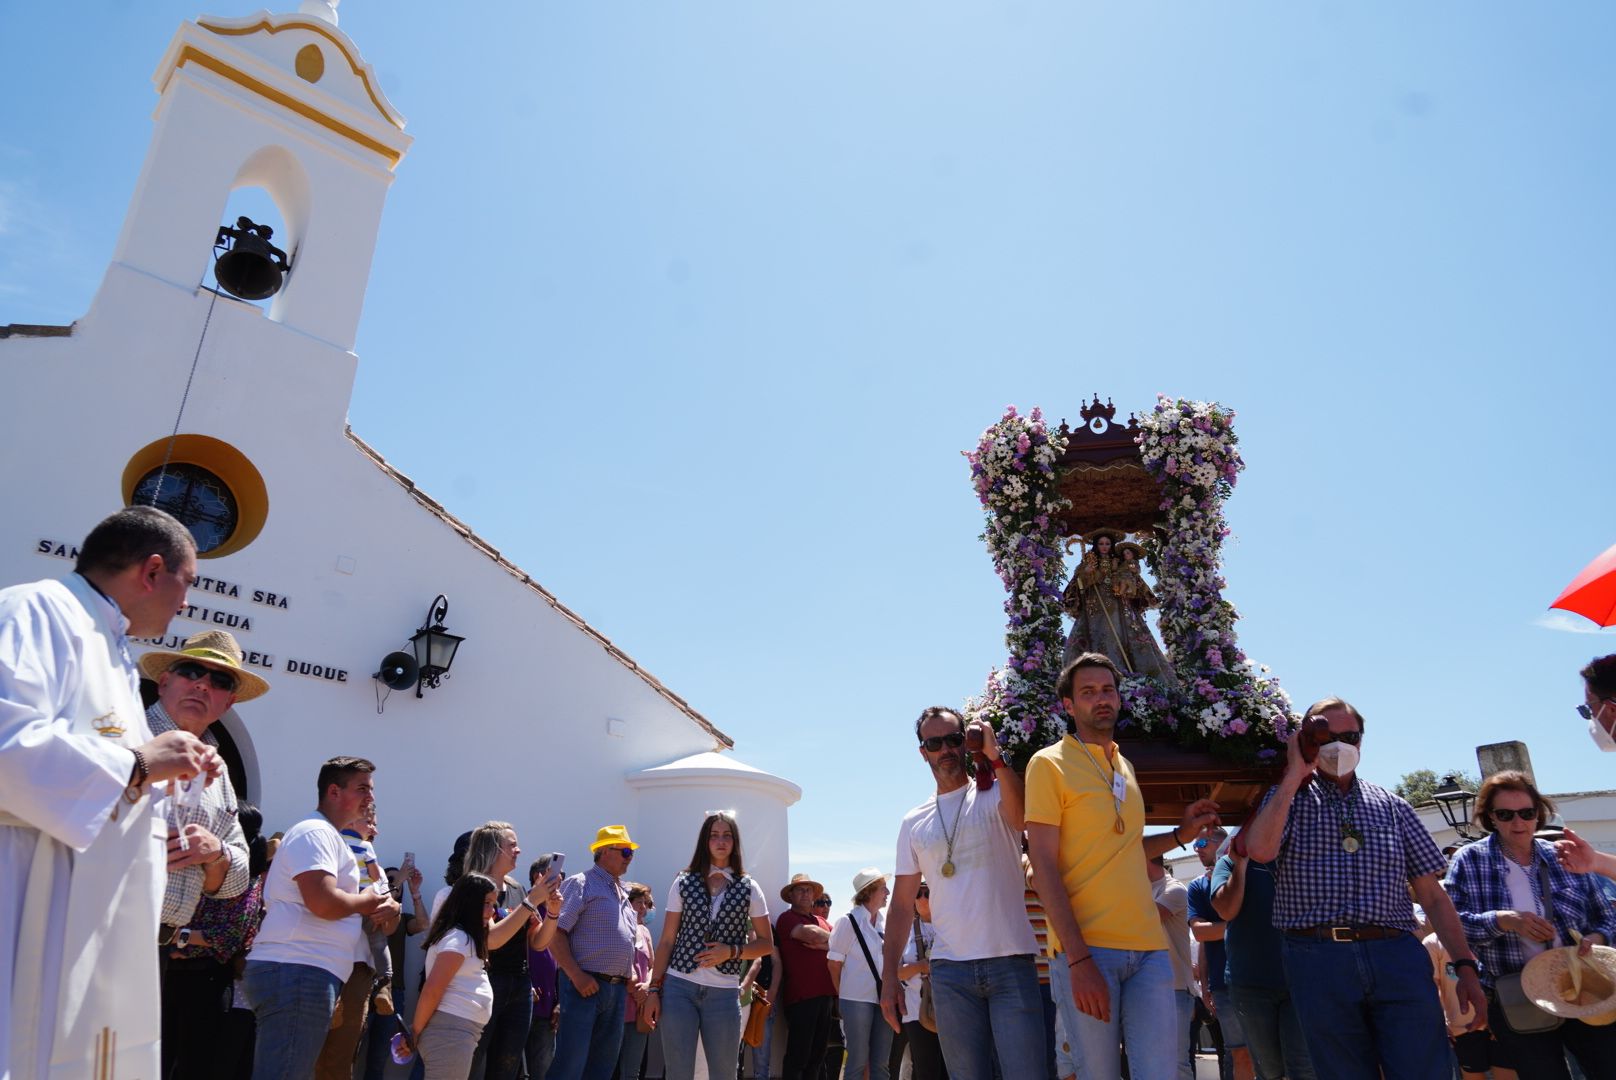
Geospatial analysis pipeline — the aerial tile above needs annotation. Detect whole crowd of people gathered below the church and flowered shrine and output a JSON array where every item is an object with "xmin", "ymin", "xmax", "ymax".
[{"xmin": 0, "ymin": 508, "xmax": 1616, "ymax": 1080}]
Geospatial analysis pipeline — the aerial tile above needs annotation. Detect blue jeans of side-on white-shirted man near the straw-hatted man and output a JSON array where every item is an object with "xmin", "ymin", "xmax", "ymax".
[{"xmin": 242, "ymin": 960, "xmax": 343, "ymax": 1080}]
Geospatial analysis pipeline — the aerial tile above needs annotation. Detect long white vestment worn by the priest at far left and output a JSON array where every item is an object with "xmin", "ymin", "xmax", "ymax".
[{"xmin": 0, "ymin": 574, "xmax": 166, "ymax": 1080}]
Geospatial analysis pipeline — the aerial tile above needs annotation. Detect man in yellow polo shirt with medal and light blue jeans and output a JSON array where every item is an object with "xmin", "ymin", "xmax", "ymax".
[{"xmin": 1026, "ymin": 653, "xmax": 1217, "ymax": 1080}]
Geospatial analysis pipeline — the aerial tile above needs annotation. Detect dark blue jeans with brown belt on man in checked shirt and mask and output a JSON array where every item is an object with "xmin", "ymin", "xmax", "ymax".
[{"xmin": 1285, "ymin": 934, "xmax": 1450, "ymax": 1080}]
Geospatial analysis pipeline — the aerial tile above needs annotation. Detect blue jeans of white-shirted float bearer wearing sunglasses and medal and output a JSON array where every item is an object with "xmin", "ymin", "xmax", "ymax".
[{"xmin": 931, "ymin": 954, "xmax": 1049, "ymax": 1080}]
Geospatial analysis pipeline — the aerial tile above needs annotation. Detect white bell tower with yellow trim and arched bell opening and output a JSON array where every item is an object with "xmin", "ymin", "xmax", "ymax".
[{"xmin": 108, "ymin": 0, "xmax": 410, "ymax": 351}]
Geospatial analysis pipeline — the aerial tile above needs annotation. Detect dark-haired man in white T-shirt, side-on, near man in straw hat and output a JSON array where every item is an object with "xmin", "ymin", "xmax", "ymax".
[{"xmin": 244, "ymin": 757, "xmax": 399, "ymax": 1080}]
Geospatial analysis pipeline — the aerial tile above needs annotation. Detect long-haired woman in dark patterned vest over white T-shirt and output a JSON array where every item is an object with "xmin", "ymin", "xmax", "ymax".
[{"xmin": 645, "ymin": 810, "xmax": 772, "ymax": 1080}]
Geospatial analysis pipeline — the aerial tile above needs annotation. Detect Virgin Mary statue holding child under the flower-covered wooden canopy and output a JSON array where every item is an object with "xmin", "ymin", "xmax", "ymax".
[{"xmin": 1060, "ymin": 529, "xmax": 1178, "ymax": 687}]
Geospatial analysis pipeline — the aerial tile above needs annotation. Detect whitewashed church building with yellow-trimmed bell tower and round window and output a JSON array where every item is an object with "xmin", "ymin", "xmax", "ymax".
[{"xmin": 0, "ymin": 0, "xmax": 802, "ymax": 1060}]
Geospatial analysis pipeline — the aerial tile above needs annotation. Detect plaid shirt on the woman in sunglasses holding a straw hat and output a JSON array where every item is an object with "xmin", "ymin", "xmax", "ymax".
[{"xmin": 1443, "ymin": 834, "xmax": 1616, "ymax": 986}]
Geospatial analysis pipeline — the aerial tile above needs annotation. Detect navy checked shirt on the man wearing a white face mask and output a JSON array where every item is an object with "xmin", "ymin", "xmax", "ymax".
[{"xmin": 1262, "ymin": 776, "xmax": 1443, "ymax": 933}]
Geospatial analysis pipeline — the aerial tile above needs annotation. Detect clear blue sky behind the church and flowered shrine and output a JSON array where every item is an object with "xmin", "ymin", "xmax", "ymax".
[{"xmin": 0, "ymin": 0, "xmax": 1616, "ymax": 909}]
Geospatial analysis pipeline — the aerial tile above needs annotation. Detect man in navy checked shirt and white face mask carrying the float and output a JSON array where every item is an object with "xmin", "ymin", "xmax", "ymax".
[{"xmin": 1235, "ymin": 697, "xmax": 1487, "ymax": 1080}]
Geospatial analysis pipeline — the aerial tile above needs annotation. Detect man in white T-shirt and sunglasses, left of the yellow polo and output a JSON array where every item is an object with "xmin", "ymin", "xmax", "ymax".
[{"xmin": 881, "ymin": 707, "xmax": 1046, "ymax": 1080}]
